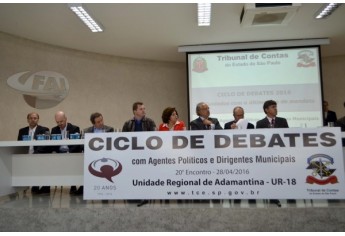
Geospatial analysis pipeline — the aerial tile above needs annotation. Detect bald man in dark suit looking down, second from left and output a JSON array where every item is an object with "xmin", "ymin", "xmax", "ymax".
[{"xmin": 51, "ymin": 111, "xmax": 84, "ymax": 195}]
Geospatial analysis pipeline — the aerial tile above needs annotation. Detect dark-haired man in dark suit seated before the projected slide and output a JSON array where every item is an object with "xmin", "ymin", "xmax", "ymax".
[{"xmin": 256, "ymin": 100, "xmax": 289, "ymax": 129}]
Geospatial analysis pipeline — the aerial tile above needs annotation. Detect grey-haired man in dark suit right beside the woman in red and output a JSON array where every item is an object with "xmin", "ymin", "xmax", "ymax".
[{"xmin": 190, "ymin": 102, "xmax": 223, "ymax": 130}]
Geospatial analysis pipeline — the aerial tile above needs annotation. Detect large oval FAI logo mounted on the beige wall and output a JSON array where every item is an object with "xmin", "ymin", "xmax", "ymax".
[{"xmin": 7, "ymin": 71, "xmax": 69, "ymax": 109}]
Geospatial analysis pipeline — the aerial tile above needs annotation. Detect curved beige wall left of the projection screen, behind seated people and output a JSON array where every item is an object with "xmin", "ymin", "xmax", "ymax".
[{"xmin": 0, "ymin": 33, "xmax": 188, "ymax": 141}]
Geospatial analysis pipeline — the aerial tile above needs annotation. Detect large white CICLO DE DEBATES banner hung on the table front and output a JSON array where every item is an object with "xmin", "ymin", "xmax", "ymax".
[{"xmin": 84, "ymin": 128, "xmax": 345, "ymax": 199}]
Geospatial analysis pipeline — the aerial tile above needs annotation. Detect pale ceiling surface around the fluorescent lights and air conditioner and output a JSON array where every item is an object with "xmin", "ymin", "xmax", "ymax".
[{"xmin": 0, "ymin": 3, "xmax": 345, "ymax": 62}]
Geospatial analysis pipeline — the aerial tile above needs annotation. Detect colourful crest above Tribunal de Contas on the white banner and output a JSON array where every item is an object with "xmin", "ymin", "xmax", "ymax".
[{"xmin": 306, "ymin": 154, "xmax": 338, "ymax": 185}]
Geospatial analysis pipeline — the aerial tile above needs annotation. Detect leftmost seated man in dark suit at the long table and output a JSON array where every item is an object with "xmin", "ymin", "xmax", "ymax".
[{"xmin": 17, "ymin": 112, "xmax": 51, "ymax": 193}]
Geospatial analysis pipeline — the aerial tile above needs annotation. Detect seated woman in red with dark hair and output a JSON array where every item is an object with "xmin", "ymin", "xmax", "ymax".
[{"xmin": 158, "ymin": 107, "xmax": 186, "ymax": 131}]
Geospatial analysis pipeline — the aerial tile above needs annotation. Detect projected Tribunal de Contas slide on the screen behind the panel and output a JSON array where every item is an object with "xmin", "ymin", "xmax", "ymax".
[{"xmin": 188, "ymin": 47, "xmax": 323, "ymax": 127}]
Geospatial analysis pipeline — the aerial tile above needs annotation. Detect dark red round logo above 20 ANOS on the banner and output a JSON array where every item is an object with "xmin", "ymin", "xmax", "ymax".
[{"xmin": 89, "ymin": 157, "xmax": 122, "ymax": 183}]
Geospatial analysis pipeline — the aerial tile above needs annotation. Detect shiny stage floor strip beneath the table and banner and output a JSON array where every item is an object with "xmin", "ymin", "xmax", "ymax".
[{"xmin": 0, "ymin": 186, "xmax": 345, "ymax": 208}]
